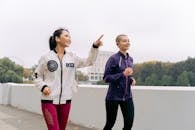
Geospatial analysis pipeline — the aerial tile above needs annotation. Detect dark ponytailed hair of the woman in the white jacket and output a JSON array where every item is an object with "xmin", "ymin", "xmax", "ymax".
[{"xmin": 49, "ymin": 28, "xmax": 69, "ymax": 50}]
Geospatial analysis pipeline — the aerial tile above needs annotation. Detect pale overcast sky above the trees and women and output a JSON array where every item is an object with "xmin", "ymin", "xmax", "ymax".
[{"xmin": 0, "ymin": 0, "xmax": 195, "ymax": 67}]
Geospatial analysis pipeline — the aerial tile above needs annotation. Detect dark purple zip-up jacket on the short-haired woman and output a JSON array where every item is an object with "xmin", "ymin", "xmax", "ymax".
[{"xmin": 103, "ymin": 51, "xmax": 133, "ymax": 101}]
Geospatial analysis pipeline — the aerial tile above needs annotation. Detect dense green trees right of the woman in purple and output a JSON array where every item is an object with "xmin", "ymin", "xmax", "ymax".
[{"xmin": 134, "ymin": 57, "xmax": 195, "ymax": 86}]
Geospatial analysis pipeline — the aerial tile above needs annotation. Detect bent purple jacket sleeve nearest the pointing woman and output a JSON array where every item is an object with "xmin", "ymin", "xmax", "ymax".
[{"xmin": 103, "ymin": 57, "xmax": 125, "ymax": 82}]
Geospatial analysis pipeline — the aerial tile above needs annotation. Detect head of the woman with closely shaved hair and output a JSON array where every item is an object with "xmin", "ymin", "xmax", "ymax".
[{"xmin": 116, "ymin": 34, "xmax": 130, "ymax": 52}]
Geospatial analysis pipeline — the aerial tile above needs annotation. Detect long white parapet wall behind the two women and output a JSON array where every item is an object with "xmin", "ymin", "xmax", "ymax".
[{"xmin": 0, "ymin": 84, "xmax": 195, "ymax": 130}]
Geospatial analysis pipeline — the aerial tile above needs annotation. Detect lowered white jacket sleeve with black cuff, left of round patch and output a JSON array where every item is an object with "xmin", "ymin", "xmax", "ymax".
[{"xmin": 34, "ymin": 57, "xmax": 47, "ymax": 91}]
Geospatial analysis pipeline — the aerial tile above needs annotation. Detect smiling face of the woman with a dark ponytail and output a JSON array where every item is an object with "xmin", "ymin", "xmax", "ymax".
[{"xmin": 56, "ymin": 30, "xmax": 71, "ymax": 48}]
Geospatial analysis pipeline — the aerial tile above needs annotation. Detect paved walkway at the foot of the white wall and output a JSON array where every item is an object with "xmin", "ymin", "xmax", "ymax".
[{"xmin": 0, "ymin": 105, "xmax": 97, "ymax": 130}]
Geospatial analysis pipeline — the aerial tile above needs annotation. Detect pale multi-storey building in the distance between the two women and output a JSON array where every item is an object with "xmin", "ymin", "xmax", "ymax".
[{"xmin": 88, "ymin": 51, "xmax": 114, "ymax": 81}]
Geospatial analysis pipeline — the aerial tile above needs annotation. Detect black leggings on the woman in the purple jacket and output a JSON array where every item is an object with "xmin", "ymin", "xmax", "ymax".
[{"xmin": 103, "ymin": 99, "xmax": 134, "ymax": 130}]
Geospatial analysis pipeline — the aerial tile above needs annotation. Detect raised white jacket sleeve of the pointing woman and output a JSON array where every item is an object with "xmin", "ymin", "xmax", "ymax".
[{"xmin": 75, "ymin": 46, "xmax": 99, "ymax": 68}]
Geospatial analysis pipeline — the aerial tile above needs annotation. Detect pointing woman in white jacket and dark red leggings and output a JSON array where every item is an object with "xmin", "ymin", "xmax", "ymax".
[{"xmin": 35, "ymin": 28, "xmax": 103, "ymax": 130}]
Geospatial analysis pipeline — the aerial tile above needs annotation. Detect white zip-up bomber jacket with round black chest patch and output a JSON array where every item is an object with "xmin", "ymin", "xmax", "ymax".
[{"xmin": 34, "ymin": 47, "xmax": 98, "ymax": 104}]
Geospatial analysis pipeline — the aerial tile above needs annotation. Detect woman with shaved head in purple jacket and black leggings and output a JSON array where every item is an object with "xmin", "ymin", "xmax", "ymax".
[{"xmin": 103, "ymin": 34, "xmax": 135, "ymax": 130}]
